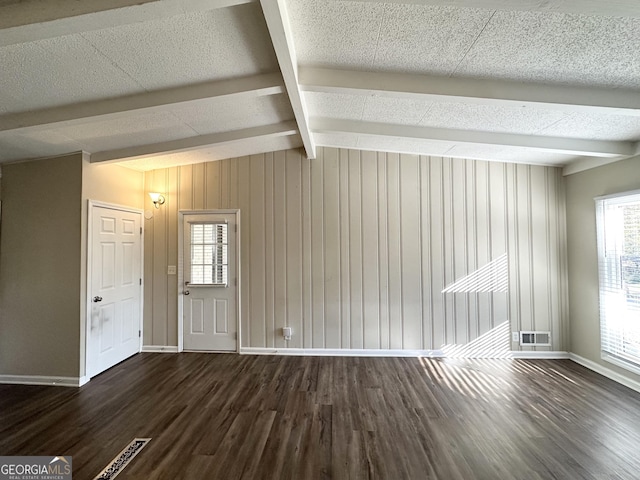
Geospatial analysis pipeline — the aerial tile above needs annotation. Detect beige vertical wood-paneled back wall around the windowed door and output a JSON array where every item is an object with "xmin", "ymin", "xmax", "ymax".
[{"xmin": 144, "ymin": 148, "xmax": 568, "ymax": 350}]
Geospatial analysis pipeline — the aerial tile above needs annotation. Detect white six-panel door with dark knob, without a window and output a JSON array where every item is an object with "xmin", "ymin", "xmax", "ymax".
[{"xmin": 87, "ymin": 205, "xmax": 142, "ymax": 377}]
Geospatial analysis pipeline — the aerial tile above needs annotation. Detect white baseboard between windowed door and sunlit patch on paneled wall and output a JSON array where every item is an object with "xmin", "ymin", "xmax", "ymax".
[{"xmin": 240, "ymin": 347, "xmax": 444, "ymax": 357}]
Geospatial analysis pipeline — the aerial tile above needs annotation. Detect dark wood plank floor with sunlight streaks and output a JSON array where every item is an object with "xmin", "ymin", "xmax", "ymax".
[{"xmin": 0, "ymin": 353, "xmax": 640, "ymax": 480}]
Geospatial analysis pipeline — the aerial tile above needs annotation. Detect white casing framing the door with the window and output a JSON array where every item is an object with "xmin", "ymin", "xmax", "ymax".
[{"xmin": 177, "ymin": 208, "xmax": 242, "ymax": 353}]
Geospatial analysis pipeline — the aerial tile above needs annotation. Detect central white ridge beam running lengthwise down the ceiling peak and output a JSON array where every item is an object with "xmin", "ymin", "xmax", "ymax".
[{"xmin": 260, "ymin": 0, "xmax": 316, "ymax": 158}]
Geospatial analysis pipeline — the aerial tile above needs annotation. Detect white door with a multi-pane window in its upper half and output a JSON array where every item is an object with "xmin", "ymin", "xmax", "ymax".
[{"xmin": 182, "ymin": 213, "xmax": 238, "ymax": 351}]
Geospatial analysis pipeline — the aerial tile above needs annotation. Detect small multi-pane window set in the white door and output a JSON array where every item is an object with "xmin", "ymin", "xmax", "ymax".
[{"xmin": 189, "ymin": 223, "xmax": 228, "ymax": 287}]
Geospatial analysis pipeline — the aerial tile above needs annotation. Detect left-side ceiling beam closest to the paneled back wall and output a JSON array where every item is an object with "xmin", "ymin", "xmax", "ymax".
[{"xmin": 91, "ymin": 121, "xmax": 298, "ymax": 163}]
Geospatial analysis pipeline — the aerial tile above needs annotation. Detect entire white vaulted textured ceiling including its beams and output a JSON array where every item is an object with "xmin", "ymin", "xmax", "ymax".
[{"xmin": 0, "ymin": 0, "xmax": 640, "ymax": 173}]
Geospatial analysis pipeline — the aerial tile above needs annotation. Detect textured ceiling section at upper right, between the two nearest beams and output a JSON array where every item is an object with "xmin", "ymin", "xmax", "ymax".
[{"xmin": 289, "ymin": 0, "xmax": 640, "ymax": 88}]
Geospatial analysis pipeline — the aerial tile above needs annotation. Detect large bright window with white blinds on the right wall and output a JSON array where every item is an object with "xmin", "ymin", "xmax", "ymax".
[{"xmin": 596, "ymin": 191, "xmax": 640, "ymax": 371}]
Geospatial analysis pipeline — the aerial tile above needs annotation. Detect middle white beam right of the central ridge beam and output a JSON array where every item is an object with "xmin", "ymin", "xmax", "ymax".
[{"xmin": 299, "ymin": 67, "xmax": 640, "ymax": 116}]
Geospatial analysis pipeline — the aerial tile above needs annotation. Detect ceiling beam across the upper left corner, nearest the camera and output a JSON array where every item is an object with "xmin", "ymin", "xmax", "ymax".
[{"xmin": 0, "ymin": 0, "xmax": 255, "ymax": 47}]
